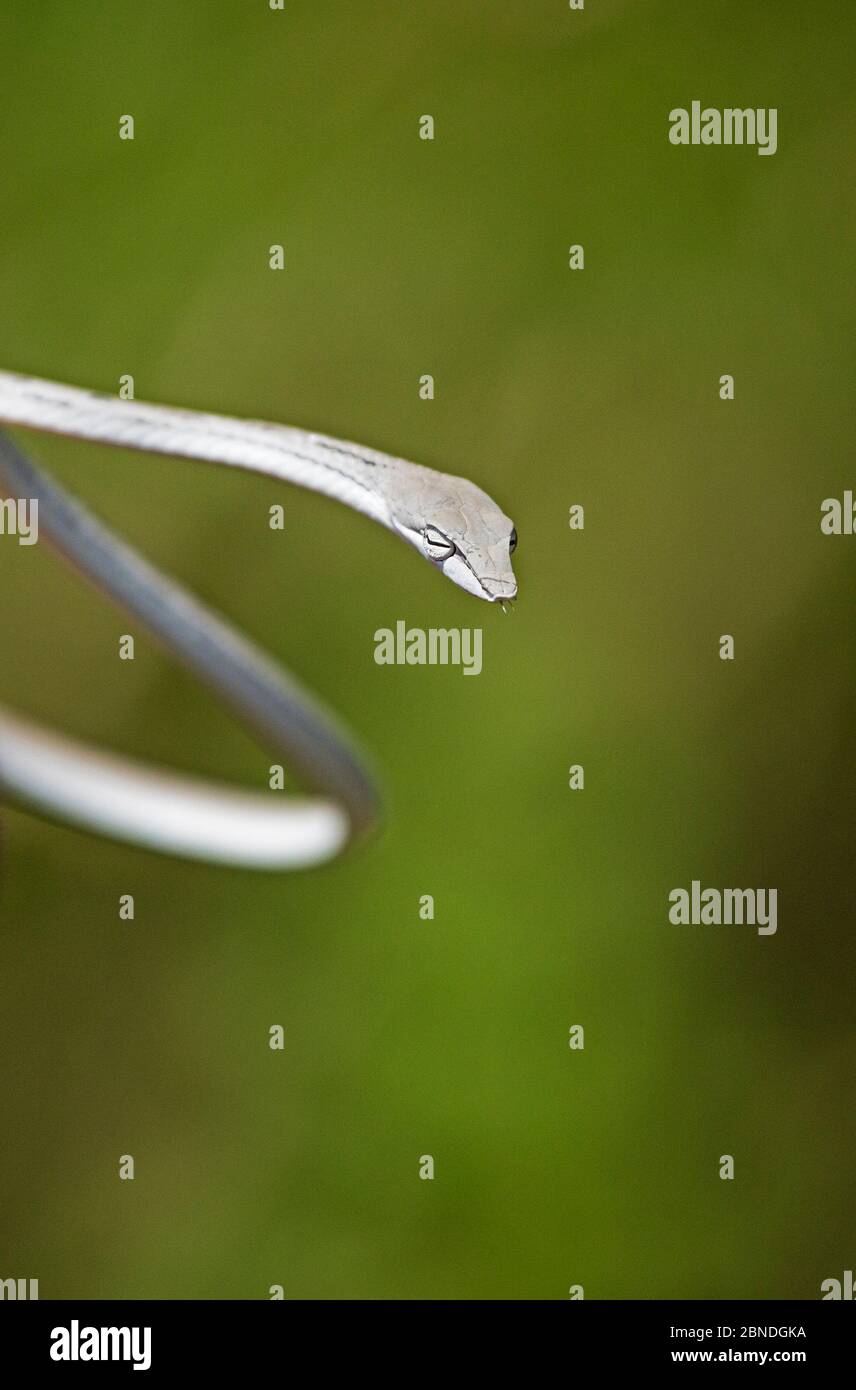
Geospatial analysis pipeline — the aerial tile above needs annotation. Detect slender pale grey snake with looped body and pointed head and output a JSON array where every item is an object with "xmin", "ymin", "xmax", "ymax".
[{"xmin": 0, "ymin": 371, "xmax": 517, "ymax": 870}]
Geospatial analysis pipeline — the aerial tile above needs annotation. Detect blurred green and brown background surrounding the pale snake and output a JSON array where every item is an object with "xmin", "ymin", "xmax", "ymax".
[{"xmin": 0, "ymin": 0, "xmax": 856, "ymax": 1300}]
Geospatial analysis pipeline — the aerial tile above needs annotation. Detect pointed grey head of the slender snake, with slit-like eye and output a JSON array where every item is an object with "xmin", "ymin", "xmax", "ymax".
[{"xmin": 390, "ymin": 464, "xmax": 517, "ymax": 603}]
